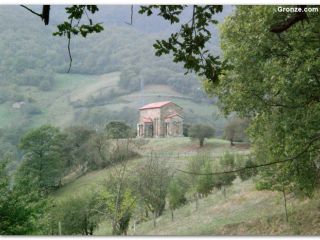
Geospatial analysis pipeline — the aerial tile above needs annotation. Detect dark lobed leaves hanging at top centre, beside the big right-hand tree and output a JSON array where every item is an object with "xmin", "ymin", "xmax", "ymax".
[{"xmin": 139, "ymin": 5, "xmax": 224, "ymax": 82}]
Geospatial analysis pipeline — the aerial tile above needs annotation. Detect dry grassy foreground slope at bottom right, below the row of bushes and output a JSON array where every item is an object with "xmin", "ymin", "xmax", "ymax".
[{"xmin": 129, "ymin": 179, "xmax": 320, "ymax": 235}]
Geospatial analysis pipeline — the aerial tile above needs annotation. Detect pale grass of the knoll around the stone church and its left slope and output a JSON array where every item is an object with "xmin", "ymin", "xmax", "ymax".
[{"xmin": 54, "ymin": 137, "xmax": 242, "ymax": 199}]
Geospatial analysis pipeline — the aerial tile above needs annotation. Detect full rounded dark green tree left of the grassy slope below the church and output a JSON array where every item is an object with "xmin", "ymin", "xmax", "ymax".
[{"xmin": 19, "ymin": 125, "xmax": 66, "ymax": 193}]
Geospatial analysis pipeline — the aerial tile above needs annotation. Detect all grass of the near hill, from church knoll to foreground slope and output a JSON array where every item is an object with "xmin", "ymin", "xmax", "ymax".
[{"xmin": 53, "ymin": 138, "xmax": 320, "ymax": 236}]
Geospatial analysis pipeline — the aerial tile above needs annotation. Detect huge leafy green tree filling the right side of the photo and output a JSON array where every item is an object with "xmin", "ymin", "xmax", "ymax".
[{"xmin": 205, "ymin": 6, "xmax": 320, "ymax": 197}]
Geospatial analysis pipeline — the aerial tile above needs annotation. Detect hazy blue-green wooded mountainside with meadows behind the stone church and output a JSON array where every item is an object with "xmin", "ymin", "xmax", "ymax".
[{"xmin": 0, "ymin": 6, "xmax": 231, "ymax": 167}]
